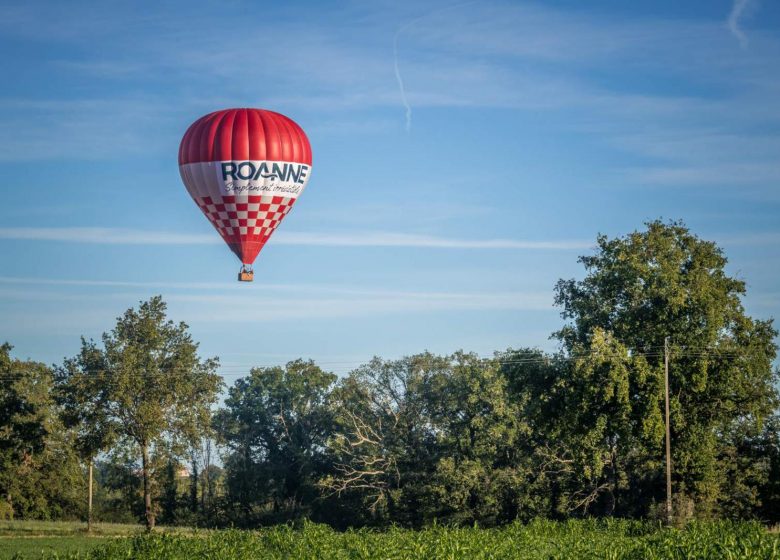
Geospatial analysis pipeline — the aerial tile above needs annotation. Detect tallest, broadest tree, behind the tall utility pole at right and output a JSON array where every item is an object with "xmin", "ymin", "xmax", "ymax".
[{"xmin": 556, "ymin": 221, "xmax": 778, "ymax": 516}]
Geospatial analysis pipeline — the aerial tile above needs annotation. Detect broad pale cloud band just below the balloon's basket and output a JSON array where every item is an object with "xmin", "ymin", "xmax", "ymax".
[{"xmin": 0, "ymin": 277, "xmax": 553, "ymax": 333}]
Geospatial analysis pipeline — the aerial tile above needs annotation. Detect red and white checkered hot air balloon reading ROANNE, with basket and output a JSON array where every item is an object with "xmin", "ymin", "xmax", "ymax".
[{"xmin": 179, "ymin": 109, "xmax": 311, "ymax": 282}]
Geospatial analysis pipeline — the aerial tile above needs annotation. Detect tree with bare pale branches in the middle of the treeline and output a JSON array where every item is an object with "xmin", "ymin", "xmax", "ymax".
[{"xmin": 321, "ymin": 352, "xmax": 450, "ymax": 525}]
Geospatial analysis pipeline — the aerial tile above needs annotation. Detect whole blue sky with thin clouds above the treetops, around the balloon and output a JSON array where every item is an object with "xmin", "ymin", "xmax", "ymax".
[{"xmin": 0, "ymin": 0, "xmax": 780, "ymax": 381}]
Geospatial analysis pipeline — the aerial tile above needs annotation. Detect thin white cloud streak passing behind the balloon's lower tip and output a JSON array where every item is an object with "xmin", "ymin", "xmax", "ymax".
[{"xmin": 0, "ymin": 227, "xmax": 593, "ymax": 250}]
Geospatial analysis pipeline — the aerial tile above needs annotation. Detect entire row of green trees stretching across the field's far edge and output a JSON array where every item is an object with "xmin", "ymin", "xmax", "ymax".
[{"xmin": 0, "ymin": 222, "xmax": 780, "ymax": 528}]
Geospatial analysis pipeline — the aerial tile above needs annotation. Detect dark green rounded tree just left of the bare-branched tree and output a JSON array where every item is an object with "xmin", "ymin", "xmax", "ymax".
[{"xmin": 214, "ymin": 360, "xmax": 336, "ymax": 520}]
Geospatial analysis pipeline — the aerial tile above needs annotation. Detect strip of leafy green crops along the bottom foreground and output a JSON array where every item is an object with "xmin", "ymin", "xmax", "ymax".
[{"xmin": 3, "ymin": 520, "xmax": 780, "ymax": 560}]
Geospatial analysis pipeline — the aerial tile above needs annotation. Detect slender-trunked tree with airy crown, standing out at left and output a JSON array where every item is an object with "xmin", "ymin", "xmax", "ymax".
[{"xmin": 60, "ymin": 296, "xmax": 222, "ymax": 530}]
